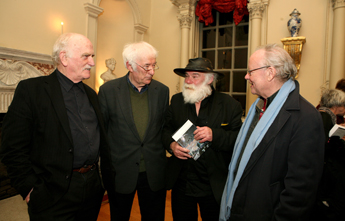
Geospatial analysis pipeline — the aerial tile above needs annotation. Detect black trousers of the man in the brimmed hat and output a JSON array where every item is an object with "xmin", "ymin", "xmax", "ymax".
[{"xmin": 171, "ymin": 189, "xmax": 220, "ymax": 221}]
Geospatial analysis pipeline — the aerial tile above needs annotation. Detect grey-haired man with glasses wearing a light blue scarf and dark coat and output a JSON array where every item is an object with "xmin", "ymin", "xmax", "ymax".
[{"xmin": 219, "ymin": 45, "xmax": 325, "ymax": 221}]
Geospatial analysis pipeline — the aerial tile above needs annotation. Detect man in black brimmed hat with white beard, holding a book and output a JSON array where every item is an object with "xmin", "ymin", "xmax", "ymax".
[{"xmin": 163, "ymin": 58, "xmax": 242, "ymax": 220}]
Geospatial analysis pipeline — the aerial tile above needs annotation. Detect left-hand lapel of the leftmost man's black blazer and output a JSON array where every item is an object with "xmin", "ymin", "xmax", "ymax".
[{"xmin": 45, "ymin": 71, "xmax": 73, "ymax": 144}]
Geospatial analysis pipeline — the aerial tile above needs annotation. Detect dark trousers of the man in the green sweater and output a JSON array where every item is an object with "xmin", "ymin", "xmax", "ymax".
[{"xmin": 108, "ymin": 172, "xmax": 166, "ymax": 221}]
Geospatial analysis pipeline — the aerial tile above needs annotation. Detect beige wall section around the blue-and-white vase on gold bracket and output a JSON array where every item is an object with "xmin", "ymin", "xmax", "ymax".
[{"xmin": 267, "ymin": 0, "xmax": 328, "ymax": 105}]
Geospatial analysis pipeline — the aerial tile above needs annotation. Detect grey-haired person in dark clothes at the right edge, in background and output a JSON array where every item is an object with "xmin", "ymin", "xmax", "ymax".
[{"xmin": 310, "ymin": 89, "xmax": 345, "ymax": 221}]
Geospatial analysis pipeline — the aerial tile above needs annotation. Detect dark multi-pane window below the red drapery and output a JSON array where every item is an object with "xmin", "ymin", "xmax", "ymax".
[{"xmin": 200, "ymin": 11, "xmax": 249, "ymax": 113}]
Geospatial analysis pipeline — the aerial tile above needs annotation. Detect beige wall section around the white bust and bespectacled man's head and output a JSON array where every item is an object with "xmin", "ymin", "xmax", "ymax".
[{"xmin": 96, "ymin": 0, "xmax": 180, "ymax": 94}]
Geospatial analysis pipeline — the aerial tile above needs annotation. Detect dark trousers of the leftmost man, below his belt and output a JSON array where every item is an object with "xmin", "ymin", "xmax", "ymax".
[{"xmin": 28, "ymin": 169, "xmax": 104, "ymax": 221}]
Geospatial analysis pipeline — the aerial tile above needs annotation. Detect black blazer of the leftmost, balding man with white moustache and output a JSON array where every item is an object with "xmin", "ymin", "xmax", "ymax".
[{"xmin": 1, "ymin": 71, "xmax": 107, "ymax": 211}]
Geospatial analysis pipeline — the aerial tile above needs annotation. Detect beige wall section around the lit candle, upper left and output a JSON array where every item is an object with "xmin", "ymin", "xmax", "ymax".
[{"xmin": 0, "ymin": 0, "xmax": 87, "ymax": 54}]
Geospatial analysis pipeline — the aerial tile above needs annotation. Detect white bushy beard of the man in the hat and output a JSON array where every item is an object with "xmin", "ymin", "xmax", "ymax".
[{"xmin": 182, "ymin": 75, "xmax": 212, "ymax": 104}]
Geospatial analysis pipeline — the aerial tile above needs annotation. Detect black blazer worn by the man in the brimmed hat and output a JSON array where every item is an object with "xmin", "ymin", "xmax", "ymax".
[{"xmin": 163, "ymin": 92, "xmax": 243, "ymax": 204}]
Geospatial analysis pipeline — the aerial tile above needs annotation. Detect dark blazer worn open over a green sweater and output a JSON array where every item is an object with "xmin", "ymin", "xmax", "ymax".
[{"xmin": 98, "ymin": 76, "xmax": 169, "ymax": 194}]
